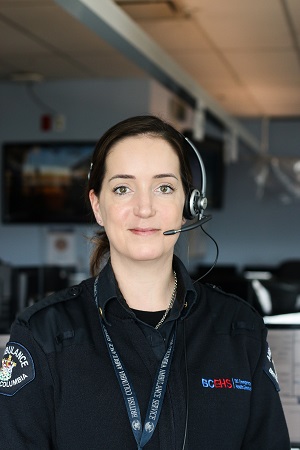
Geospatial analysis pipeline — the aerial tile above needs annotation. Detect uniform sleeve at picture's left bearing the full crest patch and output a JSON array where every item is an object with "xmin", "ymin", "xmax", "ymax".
[{"xmin": 0, "ymin": 323, "xmax": 55, "ymax": 450}]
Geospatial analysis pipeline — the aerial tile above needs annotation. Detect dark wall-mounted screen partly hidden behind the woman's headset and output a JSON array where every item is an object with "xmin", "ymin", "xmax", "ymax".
[{"xmin": 183, "ymin": 131, "xmax": 225, "ymax": 210}]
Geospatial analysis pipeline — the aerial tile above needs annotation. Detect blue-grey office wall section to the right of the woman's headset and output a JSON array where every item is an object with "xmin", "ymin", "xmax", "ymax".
[{"xmin": 198, "ymin": 118, "xmax": 300, "ymax": 267}]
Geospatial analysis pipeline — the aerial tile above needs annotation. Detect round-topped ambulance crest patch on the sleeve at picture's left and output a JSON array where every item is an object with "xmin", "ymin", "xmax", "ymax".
[{"xmin": 0, "ymin": 342, "xmax": 35, "ymax": 396}]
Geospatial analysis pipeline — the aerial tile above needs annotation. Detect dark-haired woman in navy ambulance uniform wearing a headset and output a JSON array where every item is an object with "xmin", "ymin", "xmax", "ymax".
[{"xmin": 0, "ymin": 116, "xmax": 290, "ymax": 450}]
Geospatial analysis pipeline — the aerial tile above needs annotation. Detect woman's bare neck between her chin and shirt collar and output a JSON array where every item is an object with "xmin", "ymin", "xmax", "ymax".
[{"xmin": 111, "ymin": 257, "xmax": 175, "ymax": 311}]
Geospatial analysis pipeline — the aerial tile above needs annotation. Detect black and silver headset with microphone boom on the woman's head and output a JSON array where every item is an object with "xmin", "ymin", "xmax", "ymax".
[{"xmin": 163, "ymin": 136, "xmax": 212, "ymax": 236}]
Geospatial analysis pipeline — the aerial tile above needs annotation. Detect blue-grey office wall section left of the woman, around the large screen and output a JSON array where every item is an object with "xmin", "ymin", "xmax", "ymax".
[{"xmin": 0, "ymin": 79, "xmax": 150, "ymax": 272}]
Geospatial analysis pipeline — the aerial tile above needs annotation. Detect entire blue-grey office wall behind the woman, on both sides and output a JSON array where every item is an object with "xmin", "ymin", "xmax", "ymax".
[{"xmin": 0, "ymin": 79, "xmax": 300, "ymax": 271}]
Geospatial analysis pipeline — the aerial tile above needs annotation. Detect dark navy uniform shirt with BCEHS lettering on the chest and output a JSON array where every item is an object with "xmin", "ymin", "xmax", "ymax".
[{"xmin": 0, "ymin": 258, "xmax": 290, "ymax": 450}]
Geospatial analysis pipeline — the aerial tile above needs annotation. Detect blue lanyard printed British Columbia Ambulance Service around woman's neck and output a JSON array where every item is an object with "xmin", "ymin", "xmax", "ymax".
[{"xmin": 94, "ymin": 277, "xmax": 176, "ymax": 450}]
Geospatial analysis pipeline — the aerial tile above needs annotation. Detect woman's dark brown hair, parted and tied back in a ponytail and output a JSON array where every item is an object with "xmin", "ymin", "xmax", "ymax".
[{"xmin": 86, "ymin": 115, "xmax": 192, "ymax": 276}]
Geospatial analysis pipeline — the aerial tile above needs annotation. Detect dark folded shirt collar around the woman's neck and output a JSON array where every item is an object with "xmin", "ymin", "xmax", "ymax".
[{"xmin": 97, "ymin": 255, "xmax": 197, "ymax": 322}]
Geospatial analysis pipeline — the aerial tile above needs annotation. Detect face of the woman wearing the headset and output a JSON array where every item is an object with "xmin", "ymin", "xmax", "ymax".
[{"xmin": 90, "ymin": 136, "xmax": 185, "ymax": 261}]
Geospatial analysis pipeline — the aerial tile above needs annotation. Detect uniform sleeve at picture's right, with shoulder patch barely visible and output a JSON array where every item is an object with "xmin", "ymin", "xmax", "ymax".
[{"xmin": 241, "ymin": 329, "xmax": 291, "ymax": 450}]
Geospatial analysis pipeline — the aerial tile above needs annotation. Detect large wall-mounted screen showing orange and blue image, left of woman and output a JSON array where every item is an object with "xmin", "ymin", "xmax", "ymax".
[{"xmin": 2, "ymin": 142, "xmax": 95, "ymax": 224}]
